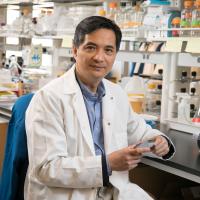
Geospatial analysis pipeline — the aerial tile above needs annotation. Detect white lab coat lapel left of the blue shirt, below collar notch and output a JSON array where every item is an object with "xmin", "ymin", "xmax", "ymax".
[{"xmin": 73, "ymin": 91, "xmax": 95, "ymax": 155}]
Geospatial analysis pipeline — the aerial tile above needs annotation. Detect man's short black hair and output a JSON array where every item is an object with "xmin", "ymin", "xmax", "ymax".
[{"xmin": 73, "ymin": 16, "xmax": 122, "ymax": 51}]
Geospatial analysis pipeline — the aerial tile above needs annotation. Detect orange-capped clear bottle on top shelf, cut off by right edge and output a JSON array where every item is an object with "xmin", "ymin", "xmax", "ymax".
[{"xmin": 191, "ymin": 0, "xmax": 200, "ymax": 37}]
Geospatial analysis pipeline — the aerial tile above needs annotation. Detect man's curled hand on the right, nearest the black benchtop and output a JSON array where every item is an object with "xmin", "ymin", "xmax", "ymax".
[{"xmin": 151, "ymin": 135, "xmax": 169, "ymax": 157}]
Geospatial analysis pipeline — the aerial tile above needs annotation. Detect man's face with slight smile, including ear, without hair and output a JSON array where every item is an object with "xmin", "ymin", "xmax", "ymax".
[{"xmin": 73, "ymin": 28, "xmax": 117, "ymax": 84}]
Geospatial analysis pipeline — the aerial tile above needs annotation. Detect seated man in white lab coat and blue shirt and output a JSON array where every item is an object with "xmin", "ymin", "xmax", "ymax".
[{"xmin": 25, "ymin": 16, "xmax": 174, "ymax": 200}]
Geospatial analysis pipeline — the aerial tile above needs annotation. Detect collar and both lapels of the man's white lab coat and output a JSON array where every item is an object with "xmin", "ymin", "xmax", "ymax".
[{"xmin": 64, "ymin": 65, "xmax": 116, "ymax": 155}]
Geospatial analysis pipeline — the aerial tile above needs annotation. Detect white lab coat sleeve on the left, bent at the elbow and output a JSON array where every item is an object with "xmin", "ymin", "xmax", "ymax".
[{"xmin": 26, "ymin": 90, "xmax": 103, "ymax": 188}]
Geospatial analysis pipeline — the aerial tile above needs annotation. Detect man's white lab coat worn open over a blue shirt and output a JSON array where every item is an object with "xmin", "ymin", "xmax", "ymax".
[{"xmin": 25, "ymin": 67, "xmax": 166, "ymax": 200}]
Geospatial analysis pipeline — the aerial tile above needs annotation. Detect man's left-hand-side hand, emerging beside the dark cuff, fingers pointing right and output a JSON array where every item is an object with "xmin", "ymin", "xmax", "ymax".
[{"xmin": 108, "ymin": 145, "xmax": 151, "ymax": 171}]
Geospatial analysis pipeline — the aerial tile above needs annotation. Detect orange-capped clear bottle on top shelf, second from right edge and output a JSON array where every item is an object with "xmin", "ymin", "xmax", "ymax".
[{"xmin": 180, "ymin": 1, "xmax": 193, "ymax": 37}]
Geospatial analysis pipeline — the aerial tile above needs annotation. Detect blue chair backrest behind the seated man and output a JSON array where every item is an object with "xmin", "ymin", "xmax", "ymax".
[{"xmin": 0, "ymin": 94, "xmax": 33, "ymax": 200}]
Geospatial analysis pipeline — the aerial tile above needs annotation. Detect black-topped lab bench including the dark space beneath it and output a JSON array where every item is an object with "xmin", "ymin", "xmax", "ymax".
[{"xmin": 130, "ymin": 125, "xmax": 200, "ymax": 200}]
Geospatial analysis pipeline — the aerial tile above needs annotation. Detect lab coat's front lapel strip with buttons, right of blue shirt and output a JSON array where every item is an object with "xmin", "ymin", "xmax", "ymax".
[{"xmin": 102, "ymin": 86, "xmax": 115, "ymax": 153}]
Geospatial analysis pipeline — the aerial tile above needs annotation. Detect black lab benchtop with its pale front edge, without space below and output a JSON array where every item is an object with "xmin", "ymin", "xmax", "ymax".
[{"xmin": 142, "ymin": 125, "xmax": 200, "ymax": 183}]
